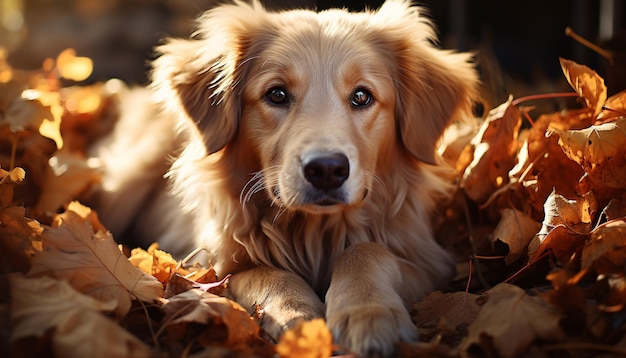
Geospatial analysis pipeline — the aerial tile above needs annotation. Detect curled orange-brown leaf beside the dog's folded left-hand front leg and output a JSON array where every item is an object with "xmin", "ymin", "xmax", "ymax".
[{"xmin": 161, "ymin": 289, "xmax": 259, "ymax": 347}]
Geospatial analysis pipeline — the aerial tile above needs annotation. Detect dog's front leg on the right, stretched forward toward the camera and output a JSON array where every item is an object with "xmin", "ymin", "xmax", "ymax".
[{"xmin": 326, "ymin": 243, "xmax": 417, "ymax": 357}]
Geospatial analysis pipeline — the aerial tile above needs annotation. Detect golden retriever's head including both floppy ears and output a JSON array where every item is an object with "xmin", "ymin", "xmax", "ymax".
[{"xmin": 153, "ymin": 0, "xmax": 477, "ymax": 212}]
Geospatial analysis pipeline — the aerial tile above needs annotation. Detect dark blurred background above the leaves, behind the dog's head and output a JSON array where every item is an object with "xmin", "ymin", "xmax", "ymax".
[{"xmin": 0, "ymin": 0, "xmax": 626, "ymax": 105}]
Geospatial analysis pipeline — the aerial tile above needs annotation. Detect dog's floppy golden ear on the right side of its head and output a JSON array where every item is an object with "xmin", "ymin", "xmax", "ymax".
[{"xmin": 375, "ymin": 0, "xmax": 479, "ymax": 164}]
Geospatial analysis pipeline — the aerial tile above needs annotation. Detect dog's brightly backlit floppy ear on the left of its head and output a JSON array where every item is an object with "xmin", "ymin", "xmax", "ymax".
[{"xmin": 152, "ymin": 1, "xmax": 266, "ymax": 153}]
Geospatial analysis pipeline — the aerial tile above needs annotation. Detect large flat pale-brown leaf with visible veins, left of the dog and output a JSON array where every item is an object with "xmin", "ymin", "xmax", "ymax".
[{"xmin": 29, "ymin": 207, "xmax": 163, "ymax": 316}]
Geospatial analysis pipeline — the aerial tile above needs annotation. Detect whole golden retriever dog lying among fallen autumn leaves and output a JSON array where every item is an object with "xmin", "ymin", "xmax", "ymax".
[{"xmin": 89, "ymin": 0, "xmax": 478, "ymax": 356}]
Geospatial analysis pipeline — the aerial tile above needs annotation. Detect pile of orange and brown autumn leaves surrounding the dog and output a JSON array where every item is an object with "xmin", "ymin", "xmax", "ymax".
[{"xmin": 0, "ymin": 46, "xmax": 626, "ymax": 357}]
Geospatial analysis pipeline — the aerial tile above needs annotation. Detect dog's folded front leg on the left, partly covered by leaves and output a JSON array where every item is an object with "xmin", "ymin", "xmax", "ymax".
[{"xmin": 228, "ymin": 267, "xmax": 324, "ymax": 338}]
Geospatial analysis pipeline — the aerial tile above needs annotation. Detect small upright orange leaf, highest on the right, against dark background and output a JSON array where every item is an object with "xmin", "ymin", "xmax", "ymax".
[{"xmin": 559, "ymin": 58, "xmax": 607, "ymax": 117}]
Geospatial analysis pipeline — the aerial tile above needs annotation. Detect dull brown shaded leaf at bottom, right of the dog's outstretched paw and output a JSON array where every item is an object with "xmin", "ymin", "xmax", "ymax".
[{"xmin": 461, "ymin": 283, "xmax": 564, "ymax": 357}]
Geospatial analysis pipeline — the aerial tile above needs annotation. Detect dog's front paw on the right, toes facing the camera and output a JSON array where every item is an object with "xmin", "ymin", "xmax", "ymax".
[{"xmin": 327, "ymin": 304, "xmax": 417, "ymax": 357}]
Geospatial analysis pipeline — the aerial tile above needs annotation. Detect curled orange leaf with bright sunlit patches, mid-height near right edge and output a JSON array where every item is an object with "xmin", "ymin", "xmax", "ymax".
[{"xmin": 528, "ymin": 191, "xmax": 597, "ymax": 262}]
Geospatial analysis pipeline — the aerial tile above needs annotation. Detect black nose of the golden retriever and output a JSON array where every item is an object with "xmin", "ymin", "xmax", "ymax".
[{"xmin": 303, "ymin": 153, "xmax": 350, "ymax": 190}]
